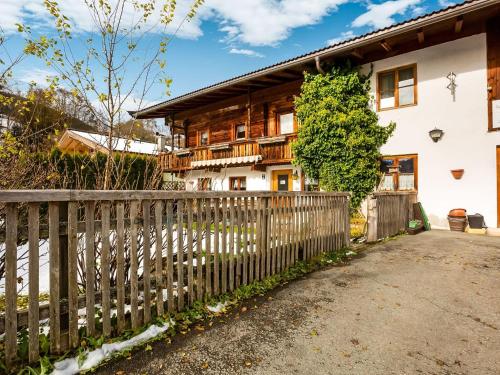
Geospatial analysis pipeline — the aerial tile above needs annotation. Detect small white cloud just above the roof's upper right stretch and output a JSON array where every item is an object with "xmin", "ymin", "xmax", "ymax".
[{"xmin": 352, "ymin": 0, "xmax": 422, "ymax": 28}]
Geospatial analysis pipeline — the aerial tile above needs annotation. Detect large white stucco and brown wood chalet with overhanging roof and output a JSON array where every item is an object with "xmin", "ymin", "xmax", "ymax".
[{"xmin": 134, "ymin": 0, "xmax": 500, "ymax": 228}]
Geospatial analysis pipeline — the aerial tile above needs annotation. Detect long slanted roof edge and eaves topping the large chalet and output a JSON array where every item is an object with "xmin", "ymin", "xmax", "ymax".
[{"xmin": 129, "ymin": 0, "xmax": 500, "ymax": 118}]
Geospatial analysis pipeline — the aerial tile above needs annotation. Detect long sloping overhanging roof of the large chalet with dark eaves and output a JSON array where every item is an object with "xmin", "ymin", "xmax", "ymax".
[{"xmin": 129, "ymin": 0, "xmax": 500, "ymax": 119}]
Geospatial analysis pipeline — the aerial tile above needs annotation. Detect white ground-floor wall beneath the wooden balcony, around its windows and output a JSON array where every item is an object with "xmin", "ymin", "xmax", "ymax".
[{"xmin": 185, "ymin": 165, "xmax": 301, "ymax": 191}]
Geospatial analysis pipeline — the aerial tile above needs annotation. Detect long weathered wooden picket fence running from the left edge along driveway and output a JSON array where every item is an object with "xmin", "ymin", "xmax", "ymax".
[{"xmin": 0, "ymin": 190, "xmax": 349, "ymax": 365}]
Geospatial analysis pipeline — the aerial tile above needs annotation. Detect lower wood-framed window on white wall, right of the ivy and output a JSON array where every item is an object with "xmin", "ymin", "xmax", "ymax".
[{"xmin": 379, "ymin": 155, "xmax": 418, "ymax": 191}]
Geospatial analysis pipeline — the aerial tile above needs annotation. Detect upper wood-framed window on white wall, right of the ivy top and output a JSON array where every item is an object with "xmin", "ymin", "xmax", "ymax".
[{"xmin": 377, "ymin": 65, "xmax": 417, "ymax": 110}]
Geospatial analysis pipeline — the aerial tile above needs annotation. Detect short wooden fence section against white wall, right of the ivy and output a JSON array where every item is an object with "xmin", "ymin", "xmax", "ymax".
[{"xmin": 367, "ymin": 192, "xmax": 417, "ymax": 242}]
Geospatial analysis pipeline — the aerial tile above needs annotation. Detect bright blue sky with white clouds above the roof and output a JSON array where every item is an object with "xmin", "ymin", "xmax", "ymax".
[{"xmin": 0, "ymin": 0, "xmax": 459, "ymax": 116}]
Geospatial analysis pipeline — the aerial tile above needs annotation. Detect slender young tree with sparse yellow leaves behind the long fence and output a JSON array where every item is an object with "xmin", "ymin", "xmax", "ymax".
[{"xmin": 26, "ymin": 0, "xmax": 203, "ymax": 189}]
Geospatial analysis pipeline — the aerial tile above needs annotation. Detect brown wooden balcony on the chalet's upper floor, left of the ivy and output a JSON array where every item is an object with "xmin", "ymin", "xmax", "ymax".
[{"xmin": 158, "ymin": 134, "xmax": 297, "ymax": 172}]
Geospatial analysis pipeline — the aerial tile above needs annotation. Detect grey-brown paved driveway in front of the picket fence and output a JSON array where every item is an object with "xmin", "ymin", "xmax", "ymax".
[{"xmin": 100, "ymin": 231, "xmax": 500, "ymax": 374}]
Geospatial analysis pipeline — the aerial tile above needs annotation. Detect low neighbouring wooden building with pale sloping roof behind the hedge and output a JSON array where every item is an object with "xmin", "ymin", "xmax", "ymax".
[{"xmin": 58, "ymin": 129, "xmax": 162, "ymax": 155}]
